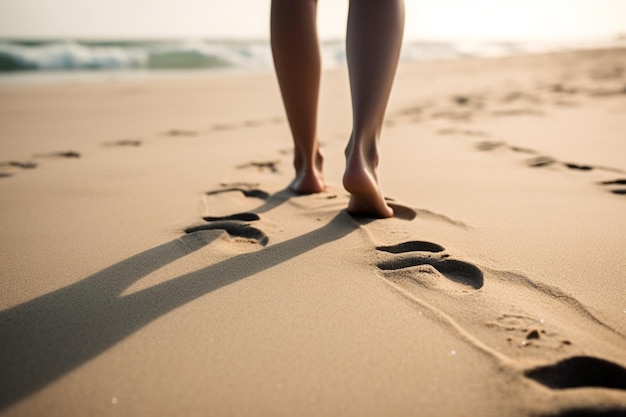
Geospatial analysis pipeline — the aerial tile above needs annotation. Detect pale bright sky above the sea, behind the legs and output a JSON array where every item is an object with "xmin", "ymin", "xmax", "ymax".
[{"xmin": 0, "ymin": 0, "xmax": 626, "ymax": 40}]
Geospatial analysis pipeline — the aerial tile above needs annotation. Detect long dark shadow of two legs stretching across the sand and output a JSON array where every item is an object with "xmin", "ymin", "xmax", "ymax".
[{"xmin": 0, "ymin": 195, "xmax": 363, "ymax": 409}]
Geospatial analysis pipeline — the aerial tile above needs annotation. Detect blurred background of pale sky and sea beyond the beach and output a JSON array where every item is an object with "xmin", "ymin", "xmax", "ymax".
[{"xmin": 0, "ymin": 0, "xmax": 626, "ymax": 84}]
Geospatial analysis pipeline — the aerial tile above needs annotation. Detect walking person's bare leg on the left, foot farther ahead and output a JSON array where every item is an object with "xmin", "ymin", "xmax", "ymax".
[{"xmin": 271, "ymin": 0, "xmax": 326, "ymax": 194}]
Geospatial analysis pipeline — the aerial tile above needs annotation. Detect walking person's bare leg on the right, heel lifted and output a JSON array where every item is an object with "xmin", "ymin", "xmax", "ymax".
[{"xmin": 343, "ymin": 0, "xmax": 404, "ymax": 218}]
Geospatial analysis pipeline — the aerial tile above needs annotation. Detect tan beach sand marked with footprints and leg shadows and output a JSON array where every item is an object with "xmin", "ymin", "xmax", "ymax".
[{"xmin": 0, "ymin": 49, "xmax": 626, "ymax": 416}]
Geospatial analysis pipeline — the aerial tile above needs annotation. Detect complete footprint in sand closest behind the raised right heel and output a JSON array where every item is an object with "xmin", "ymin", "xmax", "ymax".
[{"xmin": 376, "ymin": 241, "xmax": 483, "ymax": 293}]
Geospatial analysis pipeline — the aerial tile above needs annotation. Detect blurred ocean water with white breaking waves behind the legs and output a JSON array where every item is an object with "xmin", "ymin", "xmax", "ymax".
[{"xmin": 0, "ymin": 39, "xmax": 626, "ymax": 84}]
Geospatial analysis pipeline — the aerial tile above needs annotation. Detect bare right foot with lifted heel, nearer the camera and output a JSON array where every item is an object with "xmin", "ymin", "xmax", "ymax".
[{"xmin": 343, "ymin": 142, "xmax": 393, "ymax": 219}]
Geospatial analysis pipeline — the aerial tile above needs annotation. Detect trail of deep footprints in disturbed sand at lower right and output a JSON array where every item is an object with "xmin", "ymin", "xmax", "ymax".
[{"xmin": 375, "ymin": 237, "xmax": 626, "ymax": 416}]
